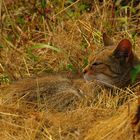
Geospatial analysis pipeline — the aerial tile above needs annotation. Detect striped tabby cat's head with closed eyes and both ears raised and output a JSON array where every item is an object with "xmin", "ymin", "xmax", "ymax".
[{"xmin": 83, "ymin": 34, "xmax": 134, "ymax": 87}]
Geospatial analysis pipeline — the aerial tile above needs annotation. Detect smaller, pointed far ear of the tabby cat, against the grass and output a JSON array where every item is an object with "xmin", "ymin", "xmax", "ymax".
[{"xmin": 103, "ymin": 33, "xmax": 114, "ymax": 47}]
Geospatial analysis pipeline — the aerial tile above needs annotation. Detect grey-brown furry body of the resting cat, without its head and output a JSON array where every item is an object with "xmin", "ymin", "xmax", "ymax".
[{"xmin": 0, "ymin": 74, "xmax": 85, "ymax": 111}]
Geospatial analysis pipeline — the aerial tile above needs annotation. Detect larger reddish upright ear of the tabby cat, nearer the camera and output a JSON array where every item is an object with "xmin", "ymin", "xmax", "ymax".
[{"xmin": 113, "ymin": 39, "xmax": 133, "ymax": 64}]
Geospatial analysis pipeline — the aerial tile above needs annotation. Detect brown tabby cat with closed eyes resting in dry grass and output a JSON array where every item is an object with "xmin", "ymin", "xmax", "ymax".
[{"xmin": 0, "ymin": 33, "xmax": 140, "ymax": 130}]
